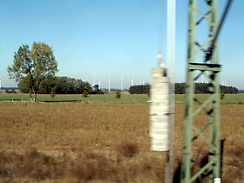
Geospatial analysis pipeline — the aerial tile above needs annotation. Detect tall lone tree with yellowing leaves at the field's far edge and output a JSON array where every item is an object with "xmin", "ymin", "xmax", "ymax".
[{"xmin": 7, "ymin": 42, "xmax": 58, "ymax": 101}]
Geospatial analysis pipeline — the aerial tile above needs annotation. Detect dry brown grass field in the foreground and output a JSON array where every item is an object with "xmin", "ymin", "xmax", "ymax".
[{"xmin": 0, "ymin": 101, "xmax": 244, "ymax": 183}]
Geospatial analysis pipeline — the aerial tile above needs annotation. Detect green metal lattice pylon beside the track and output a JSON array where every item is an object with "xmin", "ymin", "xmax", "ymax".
[{"xmin": 181, "ymin": 0, "xmax": 231, "ymax": 183}]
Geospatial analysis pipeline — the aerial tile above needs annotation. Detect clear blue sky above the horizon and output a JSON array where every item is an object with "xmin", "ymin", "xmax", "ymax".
[{"xmin": 0, "ymin": 0, "xmax": 244, "ymax": 89}]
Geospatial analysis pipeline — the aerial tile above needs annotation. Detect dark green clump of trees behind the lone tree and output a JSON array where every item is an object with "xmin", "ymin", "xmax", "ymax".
[{"xmin": 18, "ymin": 77, "xmax": 103, "ymax": 94}]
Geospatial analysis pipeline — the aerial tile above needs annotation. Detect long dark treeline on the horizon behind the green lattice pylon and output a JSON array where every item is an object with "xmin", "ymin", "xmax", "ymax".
[{"xmin": 129, "ymin": 83, "xmax": 238, "ymax": 94}]
